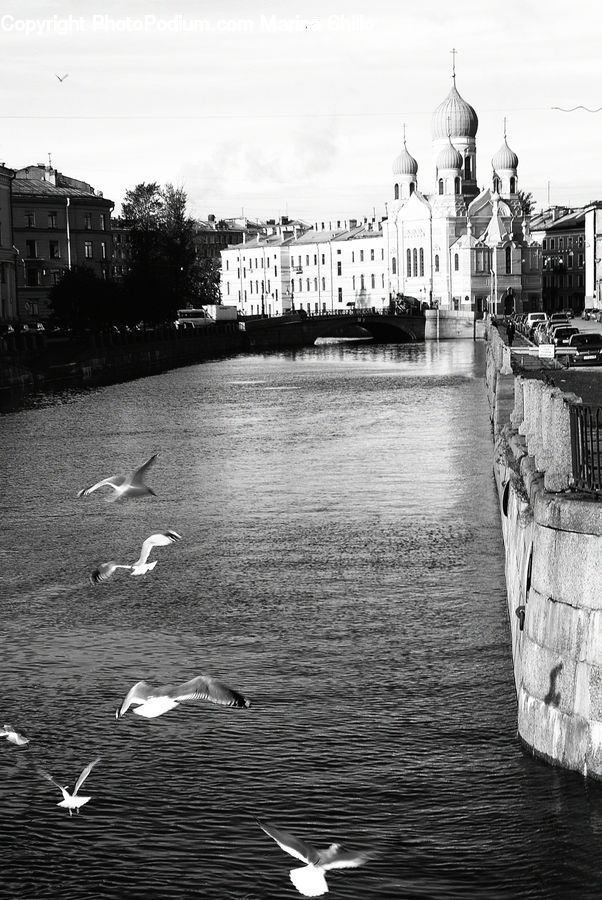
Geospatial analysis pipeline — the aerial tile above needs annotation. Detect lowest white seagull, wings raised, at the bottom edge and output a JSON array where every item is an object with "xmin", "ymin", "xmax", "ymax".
[{"xmin": 258, "ymin": 822, "xmax": 375, "ymax": 897}]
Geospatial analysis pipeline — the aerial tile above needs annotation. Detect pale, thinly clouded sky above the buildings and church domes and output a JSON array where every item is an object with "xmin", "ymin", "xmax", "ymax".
[{"xmin": 0, "ymin": 0, "xmax": 602, "ymax": 222}]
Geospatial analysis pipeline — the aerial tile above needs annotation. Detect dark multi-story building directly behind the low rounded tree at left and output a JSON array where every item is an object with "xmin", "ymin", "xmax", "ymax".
[{"xmin": 12, "ymin": 164, "xmax": 113, "ymax": 322}]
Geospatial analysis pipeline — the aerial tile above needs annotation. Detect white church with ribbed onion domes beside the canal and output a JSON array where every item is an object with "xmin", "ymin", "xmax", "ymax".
[{"xmin": 383, "ymin": 71, "xmax": 541, "ymax": 314}]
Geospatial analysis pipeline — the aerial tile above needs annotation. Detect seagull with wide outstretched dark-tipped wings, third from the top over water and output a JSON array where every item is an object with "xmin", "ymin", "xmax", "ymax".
[{"xmin": 115, "ymin": 675, "xmax": 251, "ymax": 719}]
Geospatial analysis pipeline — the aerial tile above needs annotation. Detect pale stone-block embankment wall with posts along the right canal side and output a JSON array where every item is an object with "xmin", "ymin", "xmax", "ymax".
[{"xmin": 487, "ymin": 328, "xmax": 602, "ymax": 778}]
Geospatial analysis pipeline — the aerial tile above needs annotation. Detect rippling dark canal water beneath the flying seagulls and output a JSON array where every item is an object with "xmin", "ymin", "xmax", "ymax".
[{"xmin": 0, "ymin": 341, "xmax": 602, "ymax": 900}]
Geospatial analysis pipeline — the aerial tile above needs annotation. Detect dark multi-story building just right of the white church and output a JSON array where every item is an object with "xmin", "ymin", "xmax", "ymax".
[{"xmin": 531, "ymin": 207, "xmax": 586, "ymax": 313}]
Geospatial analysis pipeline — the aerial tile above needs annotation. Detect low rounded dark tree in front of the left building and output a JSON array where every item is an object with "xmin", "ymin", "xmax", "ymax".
[{"xmin": 49, "ymin": 266, "xmax": 126, "ymax": 331}]
